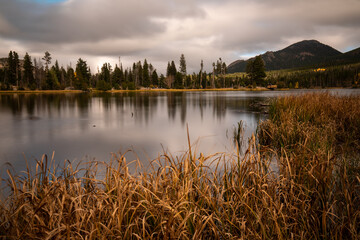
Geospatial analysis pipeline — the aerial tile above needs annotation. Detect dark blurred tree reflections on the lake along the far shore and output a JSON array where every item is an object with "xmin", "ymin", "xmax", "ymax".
[{"xmin": 0, "ymin": 92, "xmax": 262, "ymax": 125}]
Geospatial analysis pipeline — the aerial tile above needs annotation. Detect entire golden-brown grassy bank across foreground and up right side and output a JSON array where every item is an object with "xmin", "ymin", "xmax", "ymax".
[{"xmin": 0, "ymin": 94, "xmax": 360, "ymax": 239}]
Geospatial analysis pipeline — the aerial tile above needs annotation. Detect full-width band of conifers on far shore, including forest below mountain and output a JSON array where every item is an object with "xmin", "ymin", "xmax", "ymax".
[{"xmin": 0, "ymin": 51, "xmax": 360, "ymax": 91}]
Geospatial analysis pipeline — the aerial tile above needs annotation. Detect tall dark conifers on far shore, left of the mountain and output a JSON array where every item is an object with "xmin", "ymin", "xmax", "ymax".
[{"xmin": 0, "ymin": 51, "xmax": 232, "ymax": 91}]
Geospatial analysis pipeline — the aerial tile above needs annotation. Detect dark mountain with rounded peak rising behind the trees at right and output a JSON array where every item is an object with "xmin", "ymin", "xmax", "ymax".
[{"xmin": 228, "ymin": 40, "xmax": 360, "ymax": 73}]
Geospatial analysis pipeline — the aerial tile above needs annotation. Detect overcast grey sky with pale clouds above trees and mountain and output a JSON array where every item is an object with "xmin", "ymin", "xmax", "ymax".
[{"xmin": 0, "ymin": 0, "xmax": 360, "ymax": 73}]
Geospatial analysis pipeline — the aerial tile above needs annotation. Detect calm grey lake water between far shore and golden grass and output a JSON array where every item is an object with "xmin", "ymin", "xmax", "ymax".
[{"xmin": 0, "ymin": 90, "xmax": 360, "ymax": 176}]
